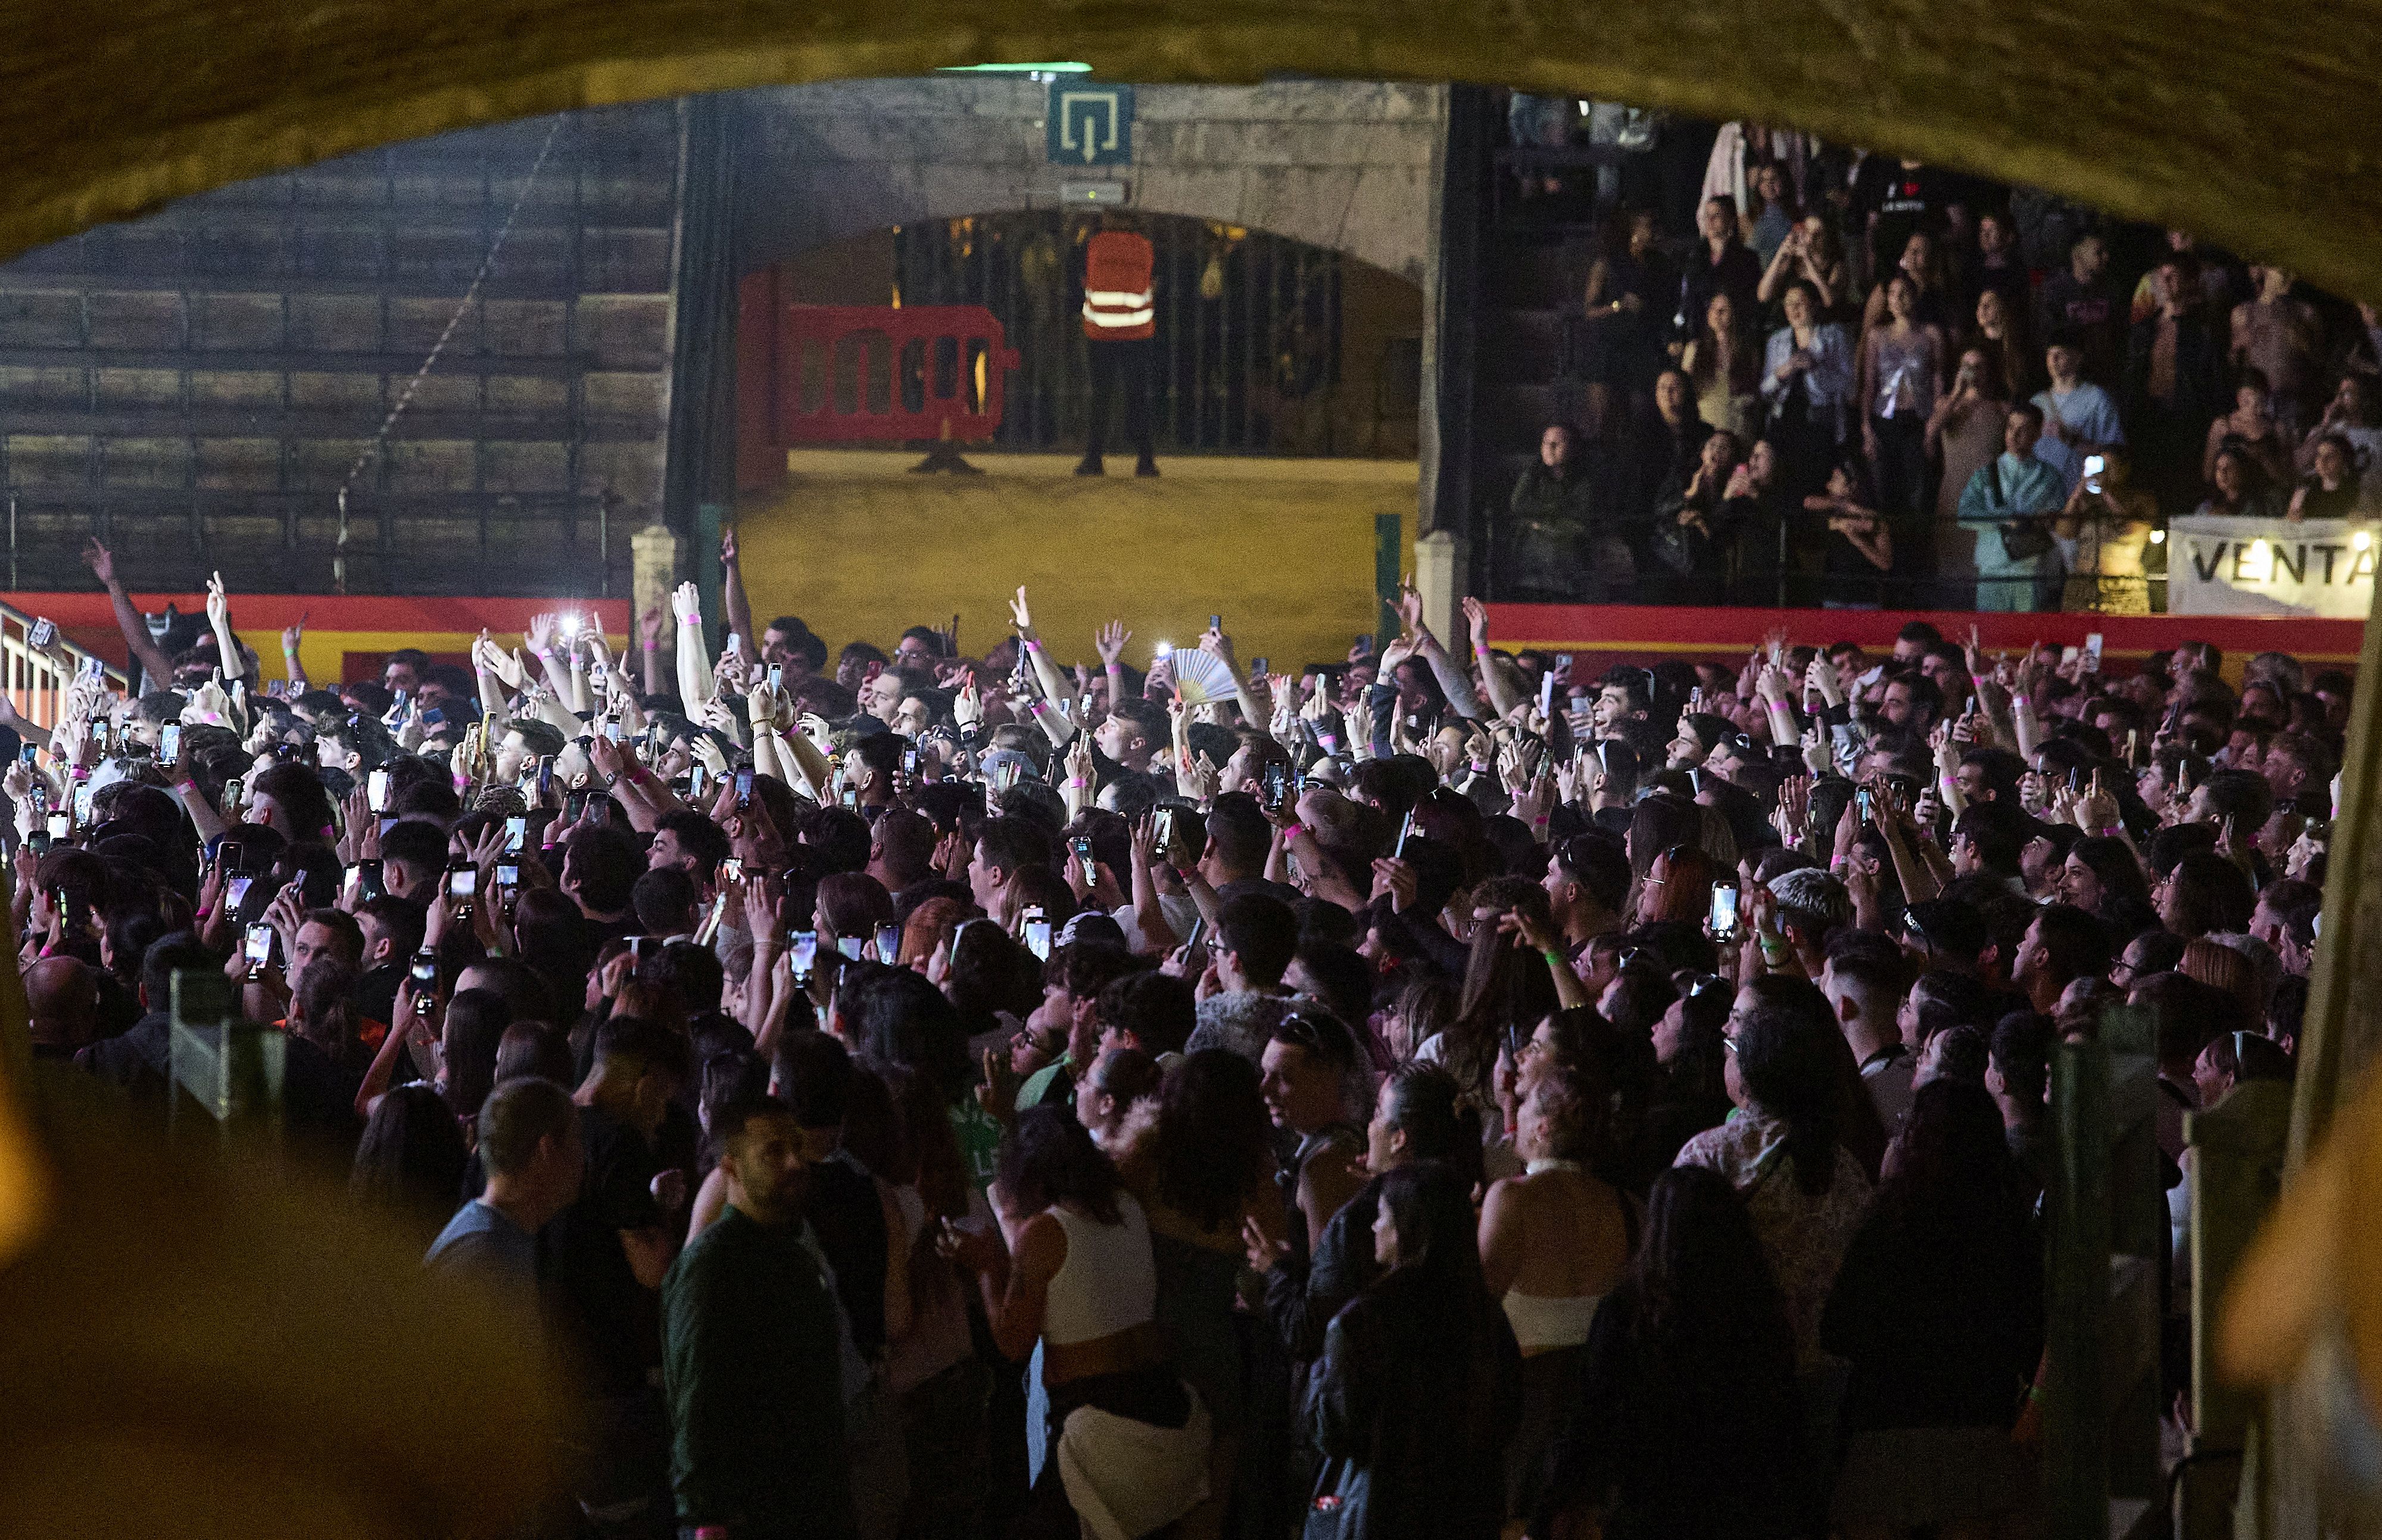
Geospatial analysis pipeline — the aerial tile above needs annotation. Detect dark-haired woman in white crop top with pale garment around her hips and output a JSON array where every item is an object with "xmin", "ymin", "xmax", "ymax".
[{"xmin": 941, "ymin": 1106, "xmax": 1208, "ymax": 1540}]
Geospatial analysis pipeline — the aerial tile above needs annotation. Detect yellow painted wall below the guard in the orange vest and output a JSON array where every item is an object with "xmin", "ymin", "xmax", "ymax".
[{"xmin": 738, "ymin": 451, "xmax": 1415, "ymax": 668}]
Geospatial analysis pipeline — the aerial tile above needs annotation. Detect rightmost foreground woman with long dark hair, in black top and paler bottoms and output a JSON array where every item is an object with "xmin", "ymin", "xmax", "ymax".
[{"xmin": 1820, "ymin": 1080, "xmax": 2044, "ymax": 1533}]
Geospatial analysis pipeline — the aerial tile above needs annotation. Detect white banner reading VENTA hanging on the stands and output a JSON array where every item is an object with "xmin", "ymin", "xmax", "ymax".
[{"xmin": 2168, "ymin": 518, "xmax": 2382, "ymax": 620}]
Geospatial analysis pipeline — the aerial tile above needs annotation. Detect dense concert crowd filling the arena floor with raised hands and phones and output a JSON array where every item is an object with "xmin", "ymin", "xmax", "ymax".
[{"xmin": 5, "ymin": 537, "xmax": 2351, "ymax": 1540}]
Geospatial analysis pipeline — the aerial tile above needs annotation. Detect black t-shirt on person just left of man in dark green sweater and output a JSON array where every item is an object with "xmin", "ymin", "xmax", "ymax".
[{"xmin": 538, "ymin": 1106, "xmax": 662, "ymax": 1397}]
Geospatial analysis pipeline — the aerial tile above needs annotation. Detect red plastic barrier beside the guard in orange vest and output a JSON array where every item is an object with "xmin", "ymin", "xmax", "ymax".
[{"xmin": 736, "ymin": 269, "xmax": 1017, "ymax": 487}]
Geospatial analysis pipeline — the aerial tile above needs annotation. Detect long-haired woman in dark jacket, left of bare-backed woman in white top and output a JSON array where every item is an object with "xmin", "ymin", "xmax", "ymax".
[{"xmin": 1308, "ymin": 1161, "xmax": 1520, "ymax": 1540}]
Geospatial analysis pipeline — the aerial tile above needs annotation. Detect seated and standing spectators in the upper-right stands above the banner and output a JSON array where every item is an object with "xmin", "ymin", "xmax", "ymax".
[{"xmin": 1496, "ymin": 114, "xmax": 2382, "ymax": 615}]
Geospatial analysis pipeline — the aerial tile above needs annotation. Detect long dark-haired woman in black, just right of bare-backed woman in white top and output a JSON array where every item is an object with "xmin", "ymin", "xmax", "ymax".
[{"xmin": 1529, "ymin": 1166, "xmax": 1820, "ymax": 1540}]
